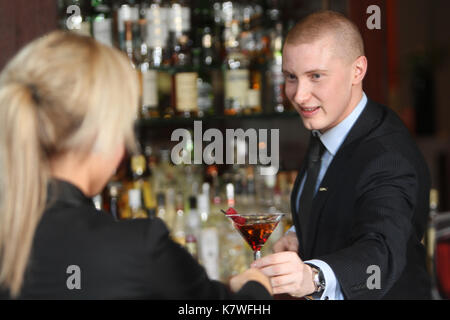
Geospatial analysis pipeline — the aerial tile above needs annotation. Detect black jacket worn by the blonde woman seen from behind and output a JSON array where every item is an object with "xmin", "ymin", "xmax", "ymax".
[{"xmin": 0, "ymin": 181, "xmax": 270, "ymax": 299}]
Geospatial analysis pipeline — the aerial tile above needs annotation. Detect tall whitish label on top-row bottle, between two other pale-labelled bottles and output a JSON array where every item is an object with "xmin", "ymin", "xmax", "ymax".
[{"xmin": 145, "ymin": 5, "xmax": 169, "ymax": 48}]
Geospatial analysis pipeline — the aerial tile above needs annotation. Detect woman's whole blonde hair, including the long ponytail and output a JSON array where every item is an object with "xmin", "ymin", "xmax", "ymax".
[{"xmin": 0, "ymin": 31, "xmax": 138, "ymax": 297}]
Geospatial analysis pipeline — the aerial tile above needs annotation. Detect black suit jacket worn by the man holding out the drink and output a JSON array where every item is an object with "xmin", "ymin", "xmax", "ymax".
[{"xmin": 291, "ymin": 100, "xmax": 430, "ymax": 299}]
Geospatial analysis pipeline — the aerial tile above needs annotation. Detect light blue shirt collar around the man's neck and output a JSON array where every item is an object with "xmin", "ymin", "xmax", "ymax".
[{"xmin": 313, "ymin": 92, "xmax": 367, "ymax": 157}]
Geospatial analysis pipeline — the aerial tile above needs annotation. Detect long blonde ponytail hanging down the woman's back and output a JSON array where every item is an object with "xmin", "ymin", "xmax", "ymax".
[{"xmin": 0, "ymin": 83, "xmax": 49, "ymax": 297}]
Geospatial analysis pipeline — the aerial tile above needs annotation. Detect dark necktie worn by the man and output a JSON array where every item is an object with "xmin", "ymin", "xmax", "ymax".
[{"xmin": 299, "ymin": 134, "xmax": 325, "ymax": 248}]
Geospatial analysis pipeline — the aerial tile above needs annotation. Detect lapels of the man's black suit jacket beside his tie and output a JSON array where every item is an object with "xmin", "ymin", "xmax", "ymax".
[{"xmin": 302, "ymin": 100, "xmax": 383, "ymax": 259}]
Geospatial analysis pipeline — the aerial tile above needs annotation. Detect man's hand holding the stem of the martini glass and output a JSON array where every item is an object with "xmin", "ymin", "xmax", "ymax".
[{"xmin": 251, "ymin": 251, "xmax": 315, "ymax": 297}]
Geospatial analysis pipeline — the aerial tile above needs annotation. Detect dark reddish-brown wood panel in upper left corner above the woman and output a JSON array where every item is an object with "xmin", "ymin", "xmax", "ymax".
[{"xmin": 0, "ymin": 0, "xmax": 58, "ymax": 69}]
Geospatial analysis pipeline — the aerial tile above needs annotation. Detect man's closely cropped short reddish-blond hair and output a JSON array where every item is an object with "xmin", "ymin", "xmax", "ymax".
[{"xmin": 285, "ymin": 10, "xmax": 364, "ymax": 59}]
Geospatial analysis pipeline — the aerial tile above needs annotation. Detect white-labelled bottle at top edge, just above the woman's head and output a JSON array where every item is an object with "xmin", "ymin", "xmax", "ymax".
[{"xmin": 91, "ymin": 0, "xmax": 113, "ymax": 47}]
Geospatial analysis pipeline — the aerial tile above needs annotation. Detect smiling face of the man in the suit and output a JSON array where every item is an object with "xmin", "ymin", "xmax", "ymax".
[{"xmin": 283, "ymin": 38, "xmax": 354, "ymax": 133}]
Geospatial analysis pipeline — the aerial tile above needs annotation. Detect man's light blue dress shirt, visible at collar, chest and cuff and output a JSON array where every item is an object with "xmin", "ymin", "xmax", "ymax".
[{"xmin": 288, "ymin": 92, "xmax": 367, "ymax": 300}]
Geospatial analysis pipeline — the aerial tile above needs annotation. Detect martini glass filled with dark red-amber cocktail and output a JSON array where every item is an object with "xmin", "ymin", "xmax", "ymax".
[{"xmin": 222, "ymin": 213, "xmax": 284, "ymax": 260}]
